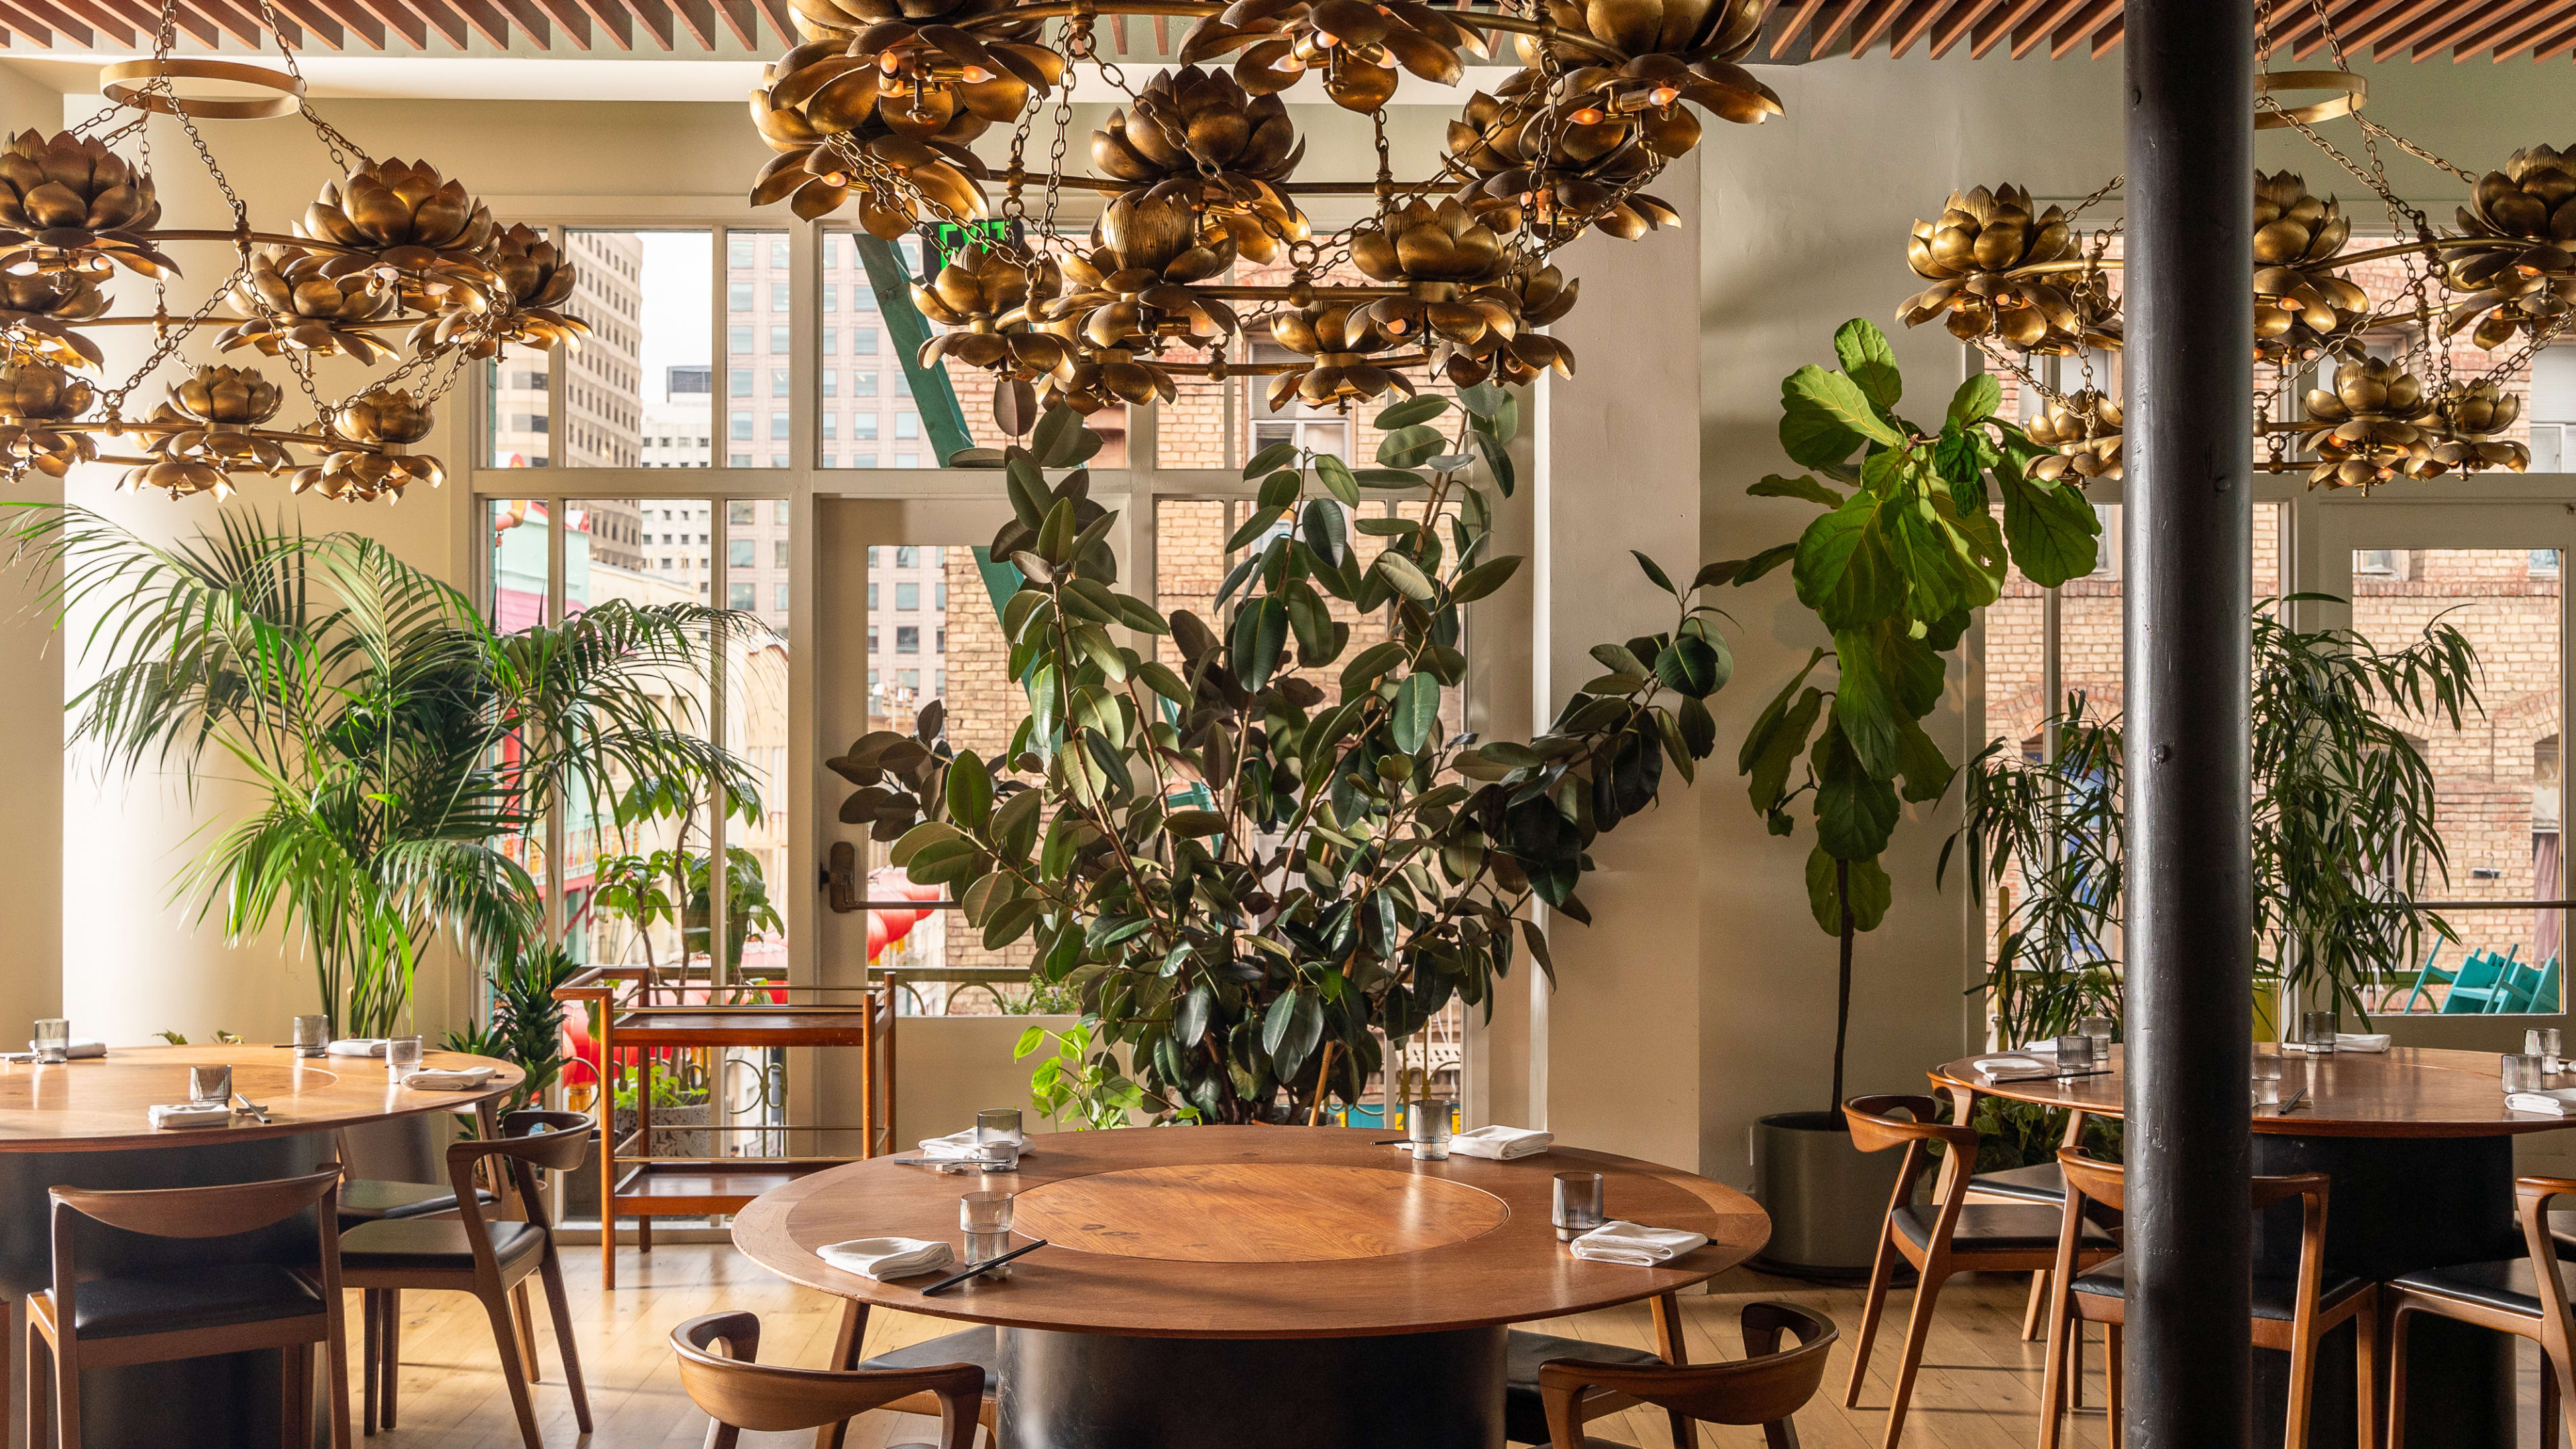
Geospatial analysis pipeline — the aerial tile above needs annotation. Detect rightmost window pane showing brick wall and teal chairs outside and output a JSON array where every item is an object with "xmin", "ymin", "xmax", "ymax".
[{"xmin": 2352, "ymin": 549, "xmax": 2566, "ymax": 1016}]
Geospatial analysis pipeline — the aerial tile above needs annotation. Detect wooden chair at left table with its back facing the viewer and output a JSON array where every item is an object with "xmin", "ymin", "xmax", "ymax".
[{"xmin": 25, "ymin": 1163, "xmax": 350, "ymax": 1449}]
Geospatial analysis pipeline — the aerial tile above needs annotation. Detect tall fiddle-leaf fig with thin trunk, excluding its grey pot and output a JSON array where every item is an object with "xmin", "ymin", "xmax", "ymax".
[{"xmin": 1705, "ymin": 317, "xmax": 2102, "ymax": 1109}]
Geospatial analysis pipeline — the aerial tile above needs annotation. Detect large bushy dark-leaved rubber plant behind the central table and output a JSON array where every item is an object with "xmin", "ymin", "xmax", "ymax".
[{"xmin": 835, "ymin": 387, "xmax": 1731, "ymax": 1122}]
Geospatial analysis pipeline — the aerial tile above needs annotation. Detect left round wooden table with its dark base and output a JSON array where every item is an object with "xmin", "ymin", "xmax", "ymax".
[{"xmin": 0, "ymin": 1046, "xmax": 523, "ymax": 1449}]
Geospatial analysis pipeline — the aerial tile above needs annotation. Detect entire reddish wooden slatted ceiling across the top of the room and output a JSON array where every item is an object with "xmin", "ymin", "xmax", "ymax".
[{"xmin": 0, "ymin": 0, "xmax": 2576, "ymax": 62}]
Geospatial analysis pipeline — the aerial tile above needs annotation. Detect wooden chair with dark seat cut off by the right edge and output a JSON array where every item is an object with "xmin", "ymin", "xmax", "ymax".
[{"xmin": 2380, "ymin": 1178, "xmax": 2576, "ymax": 1449}]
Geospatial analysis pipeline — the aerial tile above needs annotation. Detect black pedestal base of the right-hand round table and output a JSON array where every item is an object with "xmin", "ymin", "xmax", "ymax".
[{"xmin": 2254, "ymin": 1132, "xmax": 2522, "ymax": 1449}]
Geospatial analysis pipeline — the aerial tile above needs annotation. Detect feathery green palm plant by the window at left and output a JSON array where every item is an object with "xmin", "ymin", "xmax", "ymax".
[{"xmin": 8, "ymin": 505, "xmax": 760, "ymax": 1036}]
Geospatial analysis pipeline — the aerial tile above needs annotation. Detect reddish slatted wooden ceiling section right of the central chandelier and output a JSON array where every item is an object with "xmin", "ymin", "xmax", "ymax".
[{"xmin": 1782, "ymin": 0, "xmax": 2576, "ymax": 62}]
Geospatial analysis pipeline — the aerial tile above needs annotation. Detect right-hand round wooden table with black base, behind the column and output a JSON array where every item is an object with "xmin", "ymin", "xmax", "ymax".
[{"xmin": 1932, "ymin": 1044, "xmax": 2576, "ymax": 1449}]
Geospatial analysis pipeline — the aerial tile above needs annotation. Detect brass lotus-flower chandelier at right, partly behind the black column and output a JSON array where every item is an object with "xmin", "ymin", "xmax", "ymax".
[{"xmin": 1896, "ymin": 5, "xmax": 2576, "ymax": 490}]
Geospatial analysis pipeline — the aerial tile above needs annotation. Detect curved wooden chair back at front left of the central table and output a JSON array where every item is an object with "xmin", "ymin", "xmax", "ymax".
[{"xmin": 669, "ymin": 1312, "xmax": 989, "ymax": 1449}]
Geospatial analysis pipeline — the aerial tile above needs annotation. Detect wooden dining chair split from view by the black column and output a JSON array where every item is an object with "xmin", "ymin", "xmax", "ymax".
[{"xmin": 2040, "ymin": 1147, "xmax": 2380, "ymax": 1449}]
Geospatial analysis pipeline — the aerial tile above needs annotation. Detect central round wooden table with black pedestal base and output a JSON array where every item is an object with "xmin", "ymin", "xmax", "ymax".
[{"xmin": 734, "ymin": 1127, "xmax": 1770, "ymax": 1449}]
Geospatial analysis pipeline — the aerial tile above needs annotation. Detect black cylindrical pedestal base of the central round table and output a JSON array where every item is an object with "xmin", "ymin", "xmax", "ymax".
[{"xmin": 997, "ymin": 1328, "xmax": 1505, "ymax": 1449}]
